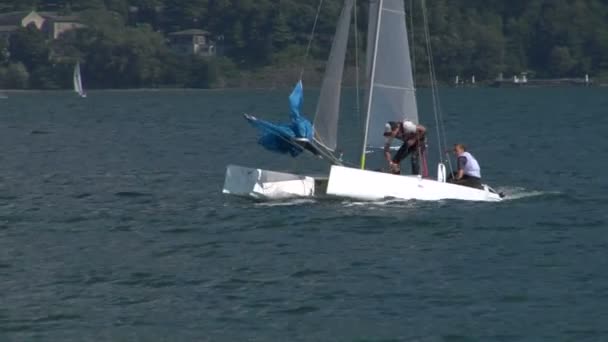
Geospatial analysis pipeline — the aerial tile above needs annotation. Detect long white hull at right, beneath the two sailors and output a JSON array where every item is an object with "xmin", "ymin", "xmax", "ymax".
[{"xmin": 327, "ymin": 165, "xmax": 502, "ymax": 202}]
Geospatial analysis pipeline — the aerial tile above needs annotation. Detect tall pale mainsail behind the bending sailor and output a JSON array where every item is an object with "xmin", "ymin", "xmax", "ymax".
[{"xmin": 364, "ymin": 0, "xmax": 418, "ymax": 148}]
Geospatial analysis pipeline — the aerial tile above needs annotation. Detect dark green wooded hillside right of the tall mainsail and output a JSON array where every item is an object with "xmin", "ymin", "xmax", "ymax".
[{"xmin": 405, "ymin": 0, "xmax": 608, "ymax": 80}]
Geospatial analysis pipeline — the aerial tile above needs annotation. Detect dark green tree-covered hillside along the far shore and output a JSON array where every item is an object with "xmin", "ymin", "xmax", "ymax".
[{"xmin": 0, "ymin": 0, "xmax": 608, "ymax": 88}]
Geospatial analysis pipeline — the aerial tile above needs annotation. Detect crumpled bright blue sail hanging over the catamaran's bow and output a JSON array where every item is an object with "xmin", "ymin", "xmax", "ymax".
[{"xmin": 245, "ymin": 81, "xmax": 313, "ymax": 157}]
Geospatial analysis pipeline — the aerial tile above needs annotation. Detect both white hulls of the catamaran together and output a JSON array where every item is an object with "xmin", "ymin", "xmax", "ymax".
[{"xmin": 222, "ymin": 165, "xmax": 502, "ymax": 202}]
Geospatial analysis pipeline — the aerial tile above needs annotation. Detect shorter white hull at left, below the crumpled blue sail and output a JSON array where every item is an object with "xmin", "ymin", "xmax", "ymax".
[{"xmin": 222, "ymin": 165, "xmax": 315, "ymax": 200}]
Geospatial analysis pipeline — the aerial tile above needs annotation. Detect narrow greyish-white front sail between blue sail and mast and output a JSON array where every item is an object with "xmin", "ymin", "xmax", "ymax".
[{"xmin": 314, "ymin": 0, "xmax": 354, "ymax": 151}]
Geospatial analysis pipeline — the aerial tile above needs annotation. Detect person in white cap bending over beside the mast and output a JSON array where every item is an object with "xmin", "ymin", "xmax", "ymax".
[{"xmin": 384, "ymin": 120, "xmax": 426, "ymax": 175}]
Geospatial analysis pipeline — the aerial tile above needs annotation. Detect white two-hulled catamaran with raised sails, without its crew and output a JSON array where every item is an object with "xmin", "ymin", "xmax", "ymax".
[{"xmin": 223, "ymin": 0, "xmax": 501, "ymax": 201}]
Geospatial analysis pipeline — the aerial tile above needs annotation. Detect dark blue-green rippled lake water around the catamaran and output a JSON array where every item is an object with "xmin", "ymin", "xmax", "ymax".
[{"xmin": 0, "ymin": 88, "xmax": 608, "ymax": 342}]
